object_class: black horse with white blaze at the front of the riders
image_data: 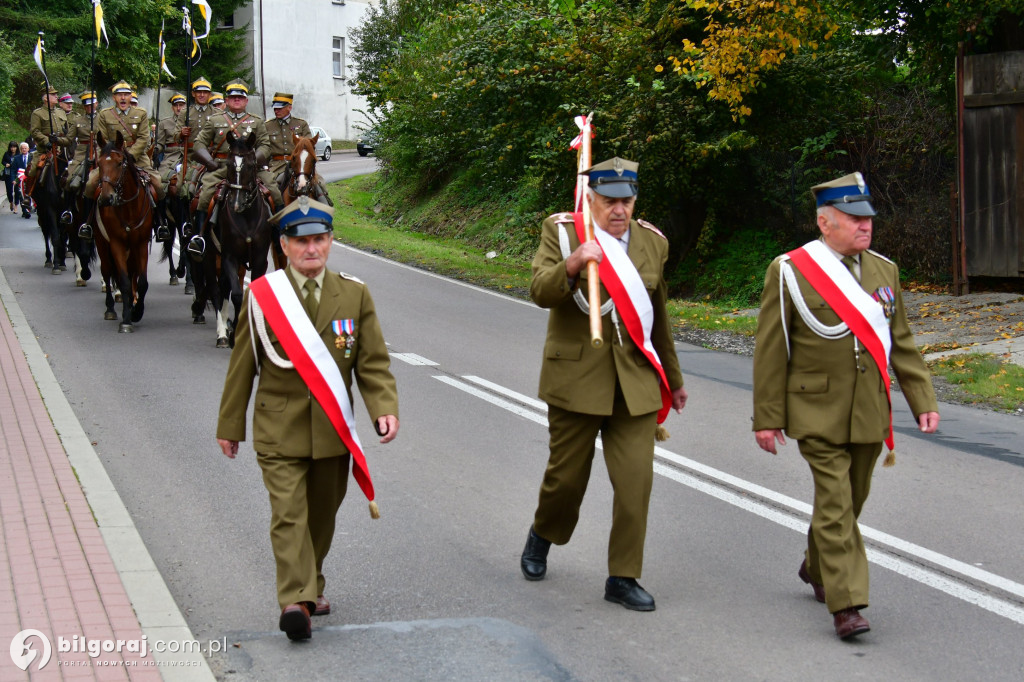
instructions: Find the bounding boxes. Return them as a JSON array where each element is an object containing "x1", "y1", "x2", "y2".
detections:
[{"x1": 193, "y1": 132, "x2": 273, "y2": 348}]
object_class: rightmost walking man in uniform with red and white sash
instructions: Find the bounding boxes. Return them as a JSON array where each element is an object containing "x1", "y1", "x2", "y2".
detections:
[{"x1": 754, "y1": 173, "x2": 939, "y2": 639}]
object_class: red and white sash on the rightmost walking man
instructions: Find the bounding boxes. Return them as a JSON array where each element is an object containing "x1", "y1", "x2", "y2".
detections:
[{"x1": 786, "y1": 240, "x2": 893, "y2": 450}]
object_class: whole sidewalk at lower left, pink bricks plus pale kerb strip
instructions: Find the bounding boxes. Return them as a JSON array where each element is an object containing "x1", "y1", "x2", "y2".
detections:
[{"x1": 0, "y1": 262, "x2": 213, "y2": 682}]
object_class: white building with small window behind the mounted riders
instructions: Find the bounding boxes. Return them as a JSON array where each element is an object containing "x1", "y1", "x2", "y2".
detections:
[{"x1": 231, "y1": 0, "x2": 377, "y2": 140}]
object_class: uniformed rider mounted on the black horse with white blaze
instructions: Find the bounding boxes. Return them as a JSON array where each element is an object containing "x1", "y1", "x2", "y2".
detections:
[{"x1": 187, "y1": 80, "x2": 282, "y2": 260}]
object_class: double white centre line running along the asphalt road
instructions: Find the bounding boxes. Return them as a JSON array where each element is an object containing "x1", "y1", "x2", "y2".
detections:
[{"x1": 434, "y1": 376, "x2": 1024, "y2": 625}]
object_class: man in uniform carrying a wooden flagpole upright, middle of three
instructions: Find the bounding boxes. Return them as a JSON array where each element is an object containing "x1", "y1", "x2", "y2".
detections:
[{"x1": 520, "y1": 157, "x2": 687, "y2": 611}]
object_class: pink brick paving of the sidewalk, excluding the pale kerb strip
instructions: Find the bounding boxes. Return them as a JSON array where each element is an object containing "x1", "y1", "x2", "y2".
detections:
[{"x1": 0, "y1": 290, "x2": 161, "y2": 680}]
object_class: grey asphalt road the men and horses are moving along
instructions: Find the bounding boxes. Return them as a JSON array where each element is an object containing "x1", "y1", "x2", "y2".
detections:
[{"x1": 0, "y1": 161, "x2": 1024, "y2": 680}]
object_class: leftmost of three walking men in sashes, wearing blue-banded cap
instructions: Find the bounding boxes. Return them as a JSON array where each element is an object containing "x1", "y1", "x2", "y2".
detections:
[{"x1": 217, "y1": 196, "x2": 398, "y2": 640}]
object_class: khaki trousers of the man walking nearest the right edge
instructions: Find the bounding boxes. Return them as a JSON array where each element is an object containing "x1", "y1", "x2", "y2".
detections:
[{"x1": 799, "y1": 438, "x2": 882, "y2": 613}]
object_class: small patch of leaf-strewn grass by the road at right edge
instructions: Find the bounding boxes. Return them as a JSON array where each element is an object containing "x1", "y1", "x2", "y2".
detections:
[{"x1": 928, "y1": 353, "x2": 1024, "y2": 412}]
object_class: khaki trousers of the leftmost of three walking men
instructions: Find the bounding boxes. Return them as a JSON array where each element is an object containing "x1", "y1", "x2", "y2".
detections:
[{"x1": 257, "y1": 453, "x2": 350, "y2": 610}]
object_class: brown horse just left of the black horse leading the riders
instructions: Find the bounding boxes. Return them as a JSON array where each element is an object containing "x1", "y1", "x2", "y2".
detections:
[{"x1": 95, "y1": 130, "x2": 154, "y2": 334}]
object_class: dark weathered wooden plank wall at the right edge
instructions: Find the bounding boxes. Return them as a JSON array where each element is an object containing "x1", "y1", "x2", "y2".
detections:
[{"x1": 963, "y1": 51, "x2": 1024, "y2": 278}]
